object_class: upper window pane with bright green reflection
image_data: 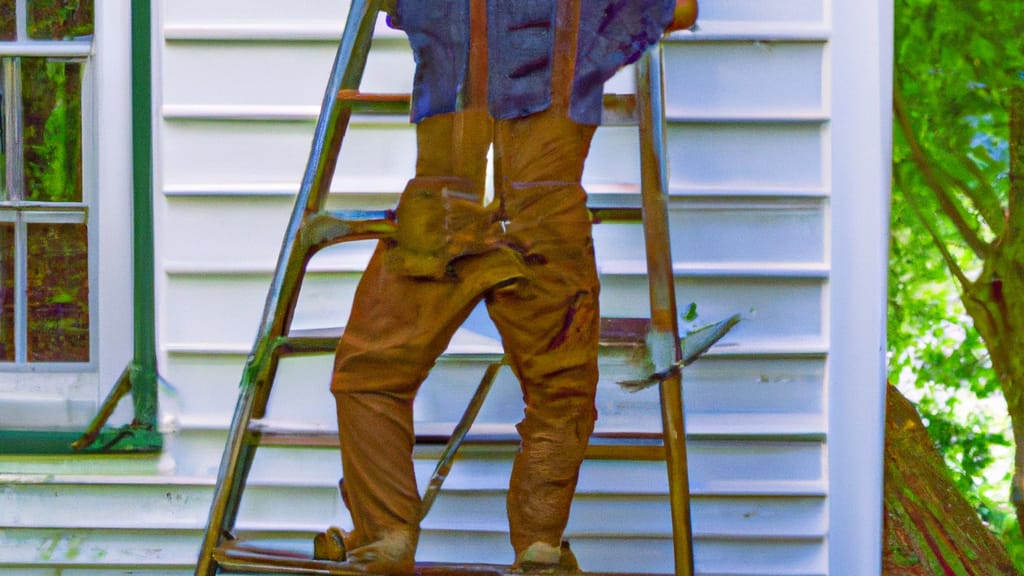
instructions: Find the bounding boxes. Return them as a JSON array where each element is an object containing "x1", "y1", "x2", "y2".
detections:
[{"x1": 22, "y1": 58, "x2": 82, "y2": 202}]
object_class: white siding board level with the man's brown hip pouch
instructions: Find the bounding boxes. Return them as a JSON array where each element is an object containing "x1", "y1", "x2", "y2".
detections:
[{"x1": 164, "y1": 197, "x2": 825, "y2": 272}]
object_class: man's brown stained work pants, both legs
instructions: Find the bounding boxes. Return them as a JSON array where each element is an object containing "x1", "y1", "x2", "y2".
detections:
[{"x1": 332, "y1": 105, "x2": 600, "y2": 553}]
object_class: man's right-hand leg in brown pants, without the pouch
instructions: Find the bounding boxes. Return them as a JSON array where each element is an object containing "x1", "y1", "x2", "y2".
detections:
[{"x1": 487, "y1": 105, "x2": 600, "y2": 563}]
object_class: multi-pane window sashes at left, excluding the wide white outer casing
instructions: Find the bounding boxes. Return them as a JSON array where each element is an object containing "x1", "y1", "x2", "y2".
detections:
[{"x1": 0, "y1": 0, "x2": 93, "y2": 370}]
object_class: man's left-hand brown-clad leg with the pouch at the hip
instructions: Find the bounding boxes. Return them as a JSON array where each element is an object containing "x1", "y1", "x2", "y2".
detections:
[{"x1": 331, "y1": 108, "x2": 522, "y2": 572}]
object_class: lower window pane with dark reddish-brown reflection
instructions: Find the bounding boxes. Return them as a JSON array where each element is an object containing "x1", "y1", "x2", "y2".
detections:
[{"x1": 28, "y1": 224, "x2": 89, "y2": 362}]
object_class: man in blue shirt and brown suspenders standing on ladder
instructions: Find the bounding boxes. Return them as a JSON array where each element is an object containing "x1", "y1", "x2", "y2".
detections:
[{"x1": 323, "y1": 0, "x2": 696, "y2": 574}]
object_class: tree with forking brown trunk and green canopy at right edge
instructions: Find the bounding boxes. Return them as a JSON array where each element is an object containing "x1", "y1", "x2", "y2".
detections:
[{"x1": 893, "y1": 0, "x2": 1024, "y2": 537}]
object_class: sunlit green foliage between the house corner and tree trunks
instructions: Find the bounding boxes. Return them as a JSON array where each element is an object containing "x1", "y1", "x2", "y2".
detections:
[{"x1": 889, "y1": 0, "x2": 1024, "y2": 569}]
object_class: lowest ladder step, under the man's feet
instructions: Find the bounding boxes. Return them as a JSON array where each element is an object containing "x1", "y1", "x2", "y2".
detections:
[{"x1": 213, "y1": 540, "x2": 667, "y2": 576}]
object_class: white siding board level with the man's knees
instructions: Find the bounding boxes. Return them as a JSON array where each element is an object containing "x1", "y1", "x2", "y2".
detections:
[{"x1": 163, "y1": 355, "x2": 824, "y2": 435}]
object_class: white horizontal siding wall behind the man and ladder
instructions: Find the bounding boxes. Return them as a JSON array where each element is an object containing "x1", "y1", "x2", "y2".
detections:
[{"x1": 160, "y1": 2, "x2": 829, "y2": 575}]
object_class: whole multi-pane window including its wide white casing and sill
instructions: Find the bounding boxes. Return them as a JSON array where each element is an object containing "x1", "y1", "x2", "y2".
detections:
[{"x1": 0, "y1": 0, "x2": 119, "y2": 438}]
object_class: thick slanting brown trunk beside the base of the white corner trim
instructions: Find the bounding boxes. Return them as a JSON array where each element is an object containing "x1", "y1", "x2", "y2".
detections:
[{"x1": 883, "y1": 386, "x2": 1018, "y2": 576}]
